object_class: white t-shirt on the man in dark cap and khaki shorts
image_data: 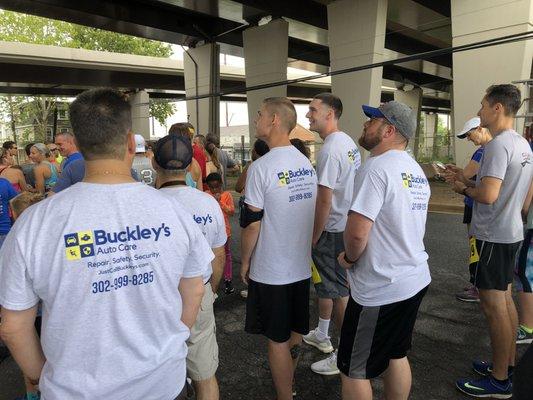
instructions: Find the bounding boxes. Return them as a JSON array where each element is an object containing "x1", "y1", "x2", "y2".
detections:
[{"x1": 160, "y1": 186, "x2": 228, "y2": 283}]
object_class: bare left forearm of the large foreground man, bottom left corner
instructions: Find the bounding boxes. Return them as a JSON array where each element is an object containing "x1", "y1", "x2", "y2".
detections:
[{"x1": 0, "y1": 305, "x2": 45, "y2": 384}]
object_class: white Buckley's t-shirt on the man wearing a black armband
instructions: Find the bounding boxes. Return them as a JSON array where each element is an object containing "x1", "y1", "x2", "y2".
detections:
[{"x1": 245, "y1": 146, "x2": 317, "y2": 285}]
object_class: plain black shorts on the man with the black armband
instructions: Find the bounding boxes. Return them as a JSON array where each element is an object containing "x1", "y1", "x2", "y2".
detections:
[{"x1": 244, "y1": 279, "x2": 310, "y2": 343}]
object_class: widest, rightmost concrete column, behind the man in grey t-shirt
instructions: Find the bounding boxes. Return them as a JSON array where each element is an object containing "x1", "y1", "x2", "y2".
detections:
[{"x1": 451, "y1": 0, "x2": 533, "y2": 167}]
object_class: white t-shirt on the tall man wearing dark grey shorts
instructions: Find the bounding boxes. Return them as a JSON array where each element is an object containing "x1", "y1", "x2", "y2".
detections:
[{"x1": 316, "y1": 132, "x2": 361, "y2": 232}]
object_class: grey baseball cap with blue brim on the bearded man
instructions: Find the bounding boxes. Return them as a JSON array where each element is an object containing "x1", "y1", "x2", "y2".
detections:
[{"x1": 363, "y1": 101, "x2": 416, "y2": 139}]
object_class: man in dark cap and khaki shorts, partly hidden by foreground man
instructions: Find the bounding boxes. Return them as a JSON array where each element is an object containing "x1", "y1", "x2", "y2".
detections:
[{"x1": 153, "y1": 135, "x2": 227, "y2": 400}]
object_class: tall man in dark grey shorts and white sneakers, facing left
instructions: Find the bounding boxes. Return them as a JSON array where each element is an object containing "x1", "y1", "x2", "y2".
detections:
[{"x1": 303, "y1": 93, "x2": 361, "y2": 375}]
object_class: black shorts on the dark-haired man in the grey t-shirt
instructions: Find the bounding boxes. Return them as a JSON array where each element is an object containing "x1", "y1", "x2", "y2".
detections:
[{"x1": 469, "y1": 239, "x2": 521, "y2": 290}]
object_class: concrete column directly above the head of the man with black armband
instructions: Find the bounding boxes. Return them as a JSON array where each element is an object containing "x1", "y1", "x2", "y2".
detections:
[{"x1": 242, "y1": 18, "x2": 289, "y2": 143}]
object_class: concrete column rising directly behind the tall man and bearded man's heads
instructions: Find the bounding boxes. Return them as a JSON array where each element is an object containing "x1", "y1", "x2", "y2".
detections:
[{"x1": 328, "y1": 0, "x2": 387, "y2": 148}]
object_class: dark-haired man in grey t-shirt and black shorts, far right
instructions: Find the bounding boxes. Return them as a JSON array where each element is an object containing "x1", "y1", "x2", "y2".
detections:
[{"x1": 448, "y1": 84, "x2": 533, "y2": 399}]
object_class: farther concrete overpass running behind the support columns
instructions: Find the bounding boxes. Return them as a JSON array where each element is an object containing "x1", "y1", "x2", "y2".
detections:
[{"x1": 0, "y1": 41, "x2": 450, "y2": 112}]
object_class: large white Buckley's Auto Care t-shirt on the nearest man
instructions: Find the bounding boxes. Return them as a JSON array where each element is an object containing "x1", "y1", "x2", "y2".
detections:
[{"x1": 0, "y1": 182, "x2": 213, "y2": 400}]
